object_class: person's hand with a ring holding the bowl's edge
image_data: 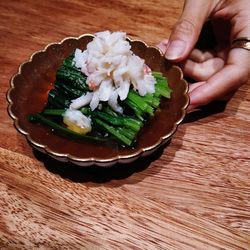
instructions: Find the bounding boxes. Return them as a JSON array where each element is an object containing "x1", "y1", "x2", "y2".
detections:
[{"x1": 158, "y1": 0, "x2": 250, "y2": 111}]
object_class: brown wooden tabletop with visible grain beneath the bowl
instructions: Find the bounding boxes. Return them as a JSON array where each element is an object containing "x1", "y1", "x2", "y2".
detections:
[{"x1": 0, "y1": 0, "x2": 250, "y2": 249}]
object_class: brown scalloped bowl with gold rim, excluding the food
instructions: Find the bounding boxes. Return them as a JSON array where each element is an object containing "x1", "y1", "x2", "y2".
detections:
[{"x1": 7, "y1": 34, "x2": 189, "y2": 166}]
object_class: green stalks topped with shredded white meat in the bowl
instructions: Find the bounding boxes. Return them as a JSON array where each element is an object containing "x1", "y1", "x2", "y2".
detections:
[{"x1": 29, "y1": 31, "x2": 171, "y2": 147}]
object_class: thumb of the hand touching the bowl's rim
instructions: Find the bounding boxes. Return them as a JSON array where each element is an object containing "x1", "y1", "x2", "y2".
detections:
[{"x1": 165, "y1": 0, "x2": 215, "y2": 62}]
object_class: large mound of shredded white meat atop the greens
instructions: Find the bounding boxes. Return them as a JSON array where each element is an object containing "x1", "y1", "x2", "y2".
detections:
[{"x1": 70, "y1": 31, "x2": 156, "y2": 113}]
